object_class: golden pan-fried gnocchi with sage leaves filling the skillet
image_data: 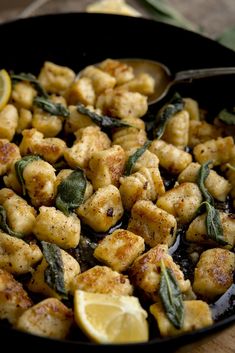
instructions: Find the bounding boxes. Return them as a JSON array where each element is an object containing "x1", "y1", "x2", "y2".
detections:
[{"x1": 0, "y1": 58, "x2": 235, "y2": 343}]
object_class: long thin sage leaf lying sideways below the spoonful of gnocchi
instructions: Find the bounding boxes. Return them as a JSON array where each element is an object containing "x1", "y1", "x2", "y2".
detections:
[{"x1": 77, "y1": 103, "x2": 130, "y2": 128}]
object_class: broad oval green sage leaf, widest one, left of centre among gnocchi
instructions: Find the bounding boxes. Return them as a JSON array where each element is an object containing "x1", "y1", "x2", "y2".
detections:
[{"x1": 55, "y1": 169, "x2": 87, "y2": 216}]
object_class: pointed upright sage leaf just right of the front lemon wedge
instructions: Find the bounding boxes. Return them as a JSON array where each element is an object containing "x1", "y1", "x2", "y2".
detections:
[{"x1": 159, "y1": 260, "x2": 184, "y2": 329}]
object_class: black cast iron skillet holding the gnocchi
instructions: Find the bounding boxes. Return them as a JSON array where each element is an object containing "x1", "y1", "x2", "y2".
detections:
[{"x1": 0, "y1": 13, "x2": 235, "y2": 353}]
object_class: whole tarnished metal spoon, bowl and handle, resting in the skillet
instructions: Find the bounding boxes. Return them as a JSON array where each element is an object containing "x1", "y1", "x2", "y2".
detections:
[{"x1": 114, "y1": 59, "x2": 235, "y2": 105}]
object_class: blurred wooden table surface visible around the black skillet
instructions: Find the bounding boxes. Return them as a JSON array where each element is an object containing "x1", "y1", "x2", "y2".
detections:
[{"x1": 0, "y1": 0, "x2": 235, "y2": 353}]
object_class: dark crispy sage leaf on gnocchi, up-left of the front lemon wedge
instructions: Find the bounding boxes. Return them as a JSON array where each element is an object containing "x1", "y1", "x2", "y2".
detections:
[{"x1": 41, "y1": 241, "x2": 67, "y2": 299}]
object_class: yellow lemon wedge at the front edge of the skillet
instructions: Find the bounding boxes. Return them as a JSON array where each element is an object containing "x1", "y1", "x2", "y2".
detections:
[{"x1": 74, "y1": 290, "x2": 148, "y2": 343}]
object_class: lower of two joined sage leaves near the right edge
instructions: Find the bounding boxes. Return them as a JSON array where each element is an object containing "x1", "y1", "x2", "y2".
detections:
[{"x1": 202, "y1": 201, "x2": 228, "y2": 245}]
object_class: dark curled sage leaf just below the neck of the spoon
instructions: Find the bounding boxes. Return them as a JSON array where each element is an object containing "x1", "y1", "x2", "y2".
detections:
[{"x1": 154, "y1": 93, "x2": 185, "y2": 139}]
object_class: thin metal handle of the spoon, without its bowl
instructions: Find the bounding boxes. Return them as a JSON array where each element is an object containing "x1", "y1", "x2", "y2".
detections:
[{"x1": 174, "y1": 67, "x2": 235, "y2": 83}]
